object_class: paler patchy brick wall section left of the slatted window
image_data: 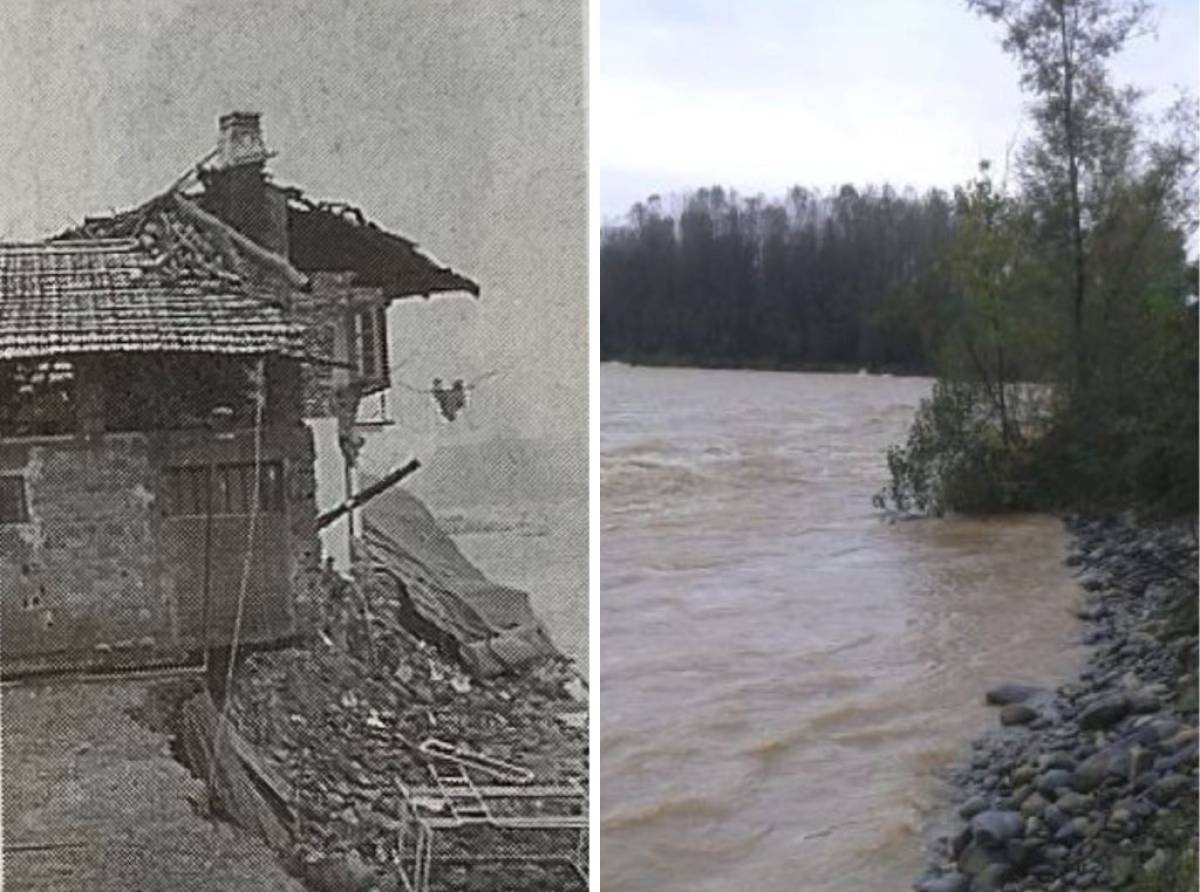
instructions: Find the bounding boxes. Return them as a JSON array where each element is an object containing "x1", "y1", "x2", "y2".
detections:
[{"x1": 0, "y1": 435, "x2": 164, "y2": 663}]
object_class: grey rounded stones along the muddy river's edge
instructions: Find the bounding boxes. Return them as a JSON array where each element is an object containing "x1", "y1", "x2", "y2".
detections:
[{"x1": 914, "y1": 517, "x2": 1198, "y2": 892}]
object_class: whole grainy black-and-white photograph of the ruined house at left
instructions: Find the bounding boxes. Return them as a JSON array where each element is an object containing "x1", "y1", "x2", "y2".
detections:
[{"x1": 0, "y1": 0, "x2": 590, "y2": 892}]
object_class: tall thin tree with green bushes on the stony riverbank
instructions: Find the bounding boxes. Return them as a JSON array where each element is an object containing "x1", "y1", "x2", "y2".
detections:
[{"x1": 880, "y1": 0, "x2": 1200, "y2": 516}]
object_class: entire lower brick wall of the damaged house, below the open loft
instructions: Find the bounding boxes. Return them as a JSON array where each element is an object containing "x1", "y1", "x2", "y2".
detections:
[{"x1": 0, "y1": 423, "x2": 320, "y2": 671}]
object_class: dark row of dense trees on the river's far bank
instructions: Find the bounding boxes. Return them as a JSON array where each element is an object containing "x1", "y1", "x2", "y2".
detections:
[{"x1": 600, "y1": 185, "x2": 954, "y2": 371}]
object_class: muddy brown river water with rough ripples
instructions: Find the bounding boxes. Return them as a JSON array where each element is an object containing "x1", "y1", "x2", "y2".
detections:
[{"x1": 600, "y1": 366, "x2": 1079, "y2": 892}]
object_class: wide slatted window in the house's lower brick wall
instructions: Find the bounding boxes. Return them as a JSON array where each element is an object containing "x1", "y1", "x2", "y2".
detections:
[{"x1": 164, "y1": 461, "x2": 283, "y2": 517}]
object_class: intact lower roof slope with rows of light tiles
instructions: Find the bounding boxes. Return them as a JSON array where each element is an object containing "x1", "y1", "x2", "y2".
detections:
[{"x1": 0, "y1": 239, "x2": 301, "y2": 360}]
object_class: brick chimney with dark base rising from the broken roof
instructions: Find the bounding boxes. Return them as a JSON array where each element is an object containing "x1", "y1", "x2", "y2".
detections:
[{"x1": 202, "y1": 112, "x2": 288, "y2": 257}]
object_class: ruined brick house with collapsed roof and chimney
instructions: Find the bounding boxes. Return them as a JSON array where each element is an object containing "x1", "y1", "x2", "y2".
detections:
[{"x1": 0, "y1": 113, "x2": 499, "y2": 672}]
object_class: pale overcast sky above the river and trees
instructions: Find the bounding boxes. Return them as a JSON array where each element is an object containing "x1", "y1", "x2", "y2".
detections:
[{"x1": 604, "y1": 0, "x2": 1200, "y2": 218}]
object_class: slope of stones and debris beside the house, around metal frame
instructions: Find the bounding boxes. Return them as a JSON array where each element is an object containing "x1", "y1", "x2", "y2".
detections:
[{"x1": 229, "y1": 554, "x2": 588, "y2": 890}]
